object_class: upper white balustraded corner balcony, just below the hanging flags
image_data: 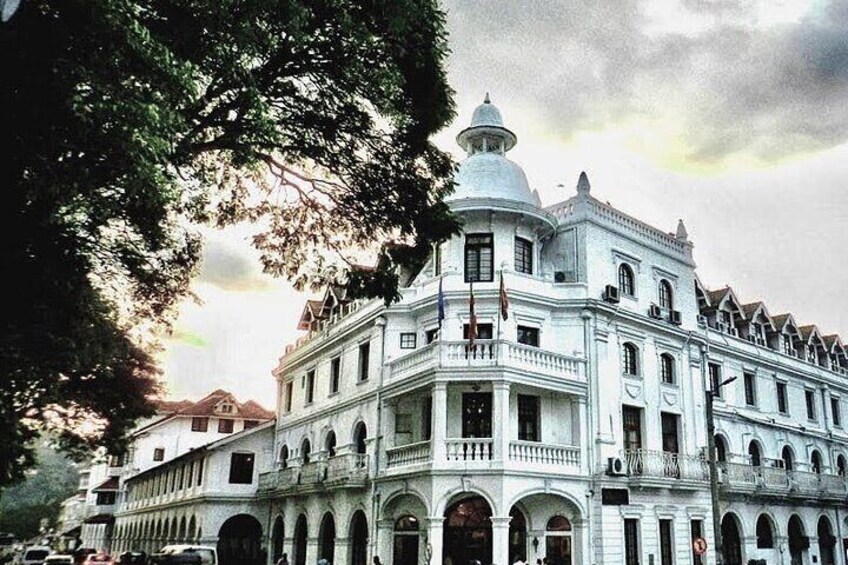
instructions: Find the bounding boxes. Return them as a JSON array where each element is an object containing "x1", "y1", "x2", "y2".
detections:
[{"x1": 388, "y1": 339, "x2": 584, "y2": 381}]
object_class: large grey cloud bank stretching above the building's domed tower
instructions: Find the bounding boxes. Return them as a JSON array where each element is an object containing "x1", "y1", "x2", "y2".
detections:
[{"x1": 447, "y1": 0, "x2": 848, "y2": 163}]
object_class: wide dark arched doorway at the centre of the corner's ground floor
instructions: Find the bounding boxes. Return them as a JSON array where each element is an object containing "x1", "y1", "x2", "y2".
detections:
[{"x1": 442, "y1": 496, "x2": 492, "y2": 565}]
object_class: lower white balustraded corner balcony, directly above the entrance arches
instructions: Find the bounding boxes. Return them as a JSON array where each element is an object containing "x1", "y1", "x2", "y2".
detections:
[{"x1": 386, "y1": 438, "x2": 582, "y2": 474}]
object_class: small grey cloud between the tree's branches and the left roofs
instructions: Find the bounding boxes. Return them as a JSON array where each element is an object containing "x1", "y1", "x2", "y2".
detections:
[{"x1": 199, "y1": 239, "x2": 270, "y2": 291}]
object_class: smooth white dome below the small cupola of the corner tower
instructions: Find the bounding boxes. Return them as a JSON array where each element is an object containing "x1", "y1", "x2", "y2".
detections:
[{"x1": 445, "y1": 153, "x2": 538, "y2": 206}]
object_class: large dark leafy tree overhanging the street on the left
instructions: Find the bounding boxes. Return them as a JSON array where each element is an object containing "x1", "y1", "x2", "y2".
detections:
[{"x1": 0, "y1": 0, "x2": 457, "y2": 485}]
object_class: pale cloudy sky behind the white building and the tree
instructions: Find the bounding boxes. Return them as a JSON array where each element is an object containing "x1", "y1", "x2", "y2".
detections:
[{"x1": 156, "y1": 0, "x2": 848, "y2": 407}]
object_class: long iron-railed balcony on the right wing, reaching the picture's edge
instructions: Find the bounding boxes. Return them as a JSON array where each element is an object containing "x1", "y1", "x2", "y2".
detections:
[{"x1": 719, "y1": 462, "x2": 848, "y2": 500}]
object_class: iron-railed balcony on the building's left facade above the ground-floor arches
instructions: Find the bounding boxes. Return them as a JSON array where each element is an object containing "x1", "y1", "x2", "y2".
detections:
[{"x1": 258, "y1": 453, "x2": 369, "y2": 494}]
